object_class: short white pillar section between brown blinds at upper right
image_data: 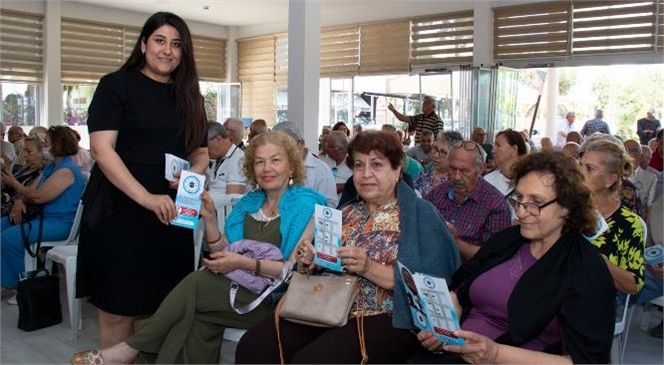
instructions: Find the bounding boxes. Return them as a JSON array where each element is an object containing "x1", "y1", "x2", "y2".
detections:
[{"x1": 473, "y1": 1, "x2": 493, "y2": 67}]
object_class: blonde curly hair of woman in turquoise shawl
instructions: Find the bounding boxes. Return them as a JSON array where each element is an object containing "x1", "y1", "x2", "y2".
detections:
[{"x1": 242, "y1": 131, "x2": 306, "y2": 186}]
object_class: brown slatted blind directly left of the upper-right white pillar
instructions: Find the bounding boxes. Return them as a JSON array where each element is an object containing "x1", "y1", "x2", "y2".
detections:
[{"x1": 410, "y1": 10, "x2": 474, "y2": 66}]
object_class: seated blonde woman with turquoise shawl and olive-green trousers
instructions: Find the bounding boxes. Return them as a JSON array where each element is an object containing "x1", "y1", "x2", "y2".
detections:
[{"x1": 72, "y1": 132, "x2": 326, "y2": 364}]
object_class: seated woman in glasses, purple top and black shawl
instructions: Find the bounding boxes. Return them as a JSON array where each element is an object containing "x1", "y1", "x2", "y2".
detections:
[{"x1": 414, "y1": 152, "x2": 615, "y2": 364}]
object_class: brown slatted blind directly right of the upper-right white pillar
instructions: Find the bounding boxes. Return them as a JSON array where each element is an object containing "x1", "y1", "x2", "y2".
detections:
[{"x1": 493, "y1": 1, "x2": 571, "y2": 61}]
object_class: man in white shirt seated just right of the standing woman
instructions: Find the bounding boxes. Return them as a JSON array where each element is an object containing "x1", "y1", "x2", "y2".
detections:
[{"x1": 207, "y1": 122, "x2": 247, "y2": 208}]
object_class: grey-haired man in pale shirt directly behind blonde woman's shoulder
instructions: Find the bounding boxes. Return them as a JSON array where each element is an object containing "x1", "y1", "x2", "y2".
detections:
[{"x1": 272, "y1": 122, "x2": 339, "y2": 208}]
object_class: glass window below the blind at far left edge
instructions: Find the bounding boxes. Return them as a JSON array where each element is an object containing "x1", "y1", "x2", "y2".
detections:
[{"x1": 0, "y1": 82, "x2": 40, "y2": 126}]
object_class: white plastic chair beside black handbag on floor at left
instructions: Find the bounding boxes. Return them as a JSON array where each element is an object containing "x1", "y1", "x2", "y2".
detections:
[{"x1": 45, "y1": 245, "x2": 83, "y2": 341}]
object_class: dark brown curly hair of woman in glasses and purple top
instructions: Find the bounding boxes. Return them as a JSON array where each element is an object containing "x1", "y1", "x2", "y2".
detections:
[{"x1": 513, "y1": 151, "x2": 597, "y2": 236}]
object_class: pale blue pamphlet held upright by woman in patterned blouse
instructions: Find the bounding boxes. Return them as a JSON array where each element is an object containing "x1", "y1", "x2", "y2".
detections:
[{"x1": 314, "y1": 204, "x2": 342, "y2": 272}]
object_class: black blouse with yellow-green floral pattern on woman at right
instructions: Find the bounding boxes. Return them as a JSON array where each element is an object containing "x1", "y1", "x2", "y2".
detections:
[{"x1": 592, "y1": 205, "x2": 646, "y2": 290}]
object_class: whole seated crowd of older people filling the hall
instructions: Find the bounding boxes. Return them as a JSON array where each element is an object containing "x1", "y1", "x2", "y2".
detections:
[{"x1": 2, "y1": 114, "x2": 664, "y2": 364}]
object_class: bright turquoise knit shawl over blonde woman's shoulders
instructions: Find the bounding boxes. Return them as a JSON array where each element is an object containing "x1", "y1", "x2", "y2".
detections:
[{"x1": 224, "y1": 185, "x2": 327, "y2": 259}]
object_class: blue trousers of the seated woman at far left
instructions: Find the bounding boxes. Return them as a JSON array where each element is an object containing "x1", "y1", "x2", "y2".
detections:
[{"x1": 0, "y1": 217, "x2": 73, "y2": 288}]
